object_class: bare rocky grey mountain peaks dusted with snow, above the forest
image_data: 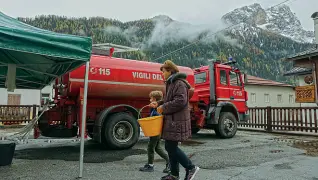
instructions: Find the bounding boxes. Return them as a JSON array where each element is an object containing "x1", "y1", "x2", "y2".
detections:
[{"x1": 222, "y1": 3, "x2": 314, "y2": 43}]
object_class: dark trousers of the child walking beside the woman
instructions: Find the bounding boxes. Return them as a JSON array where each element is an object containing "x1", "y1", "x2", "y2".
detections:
[{"x1": 148, "y1": 136, "x2": 169, "y2": 164}]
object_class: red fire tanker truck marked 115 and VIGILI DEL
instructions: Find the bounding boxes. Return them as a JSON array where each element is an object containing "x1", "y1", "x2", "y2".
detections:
[{"x1": 38, "y1": 47, "x2": 248, "y2": 149}]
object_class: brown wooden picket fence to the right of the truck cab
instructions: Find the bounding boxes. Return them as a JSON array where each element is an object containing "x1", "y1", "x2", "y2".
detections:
[{"x1": 239, "y1": 107, "x2": 318, "y2": 133}]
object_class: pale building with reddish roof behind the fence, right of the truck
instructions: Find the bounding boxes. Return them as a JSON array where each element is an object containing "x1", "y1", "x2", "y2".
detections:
[{"x1": 245, "y1": 75, "x2": 300, "y2": 107}]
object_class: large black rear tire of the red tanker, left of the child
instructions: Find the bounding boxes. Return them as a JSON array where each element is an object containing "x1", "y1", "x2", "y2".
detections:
[{"x1": 102, "y1": 113, "x2": 140, "y2": 149}]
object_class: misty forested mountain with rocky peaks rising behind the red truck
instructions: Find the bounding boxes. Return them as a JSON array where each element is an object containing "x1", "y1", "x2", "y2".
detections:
[{"x1": 18, "y1": 4, "x2": 312, "y2": 83}]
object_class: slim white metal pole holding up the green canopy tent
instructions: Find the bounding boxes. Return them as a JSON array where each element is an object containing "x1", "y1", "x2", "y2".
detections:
[{"x1": 79, "y1": 61, "x2": 89, "y2": 178}]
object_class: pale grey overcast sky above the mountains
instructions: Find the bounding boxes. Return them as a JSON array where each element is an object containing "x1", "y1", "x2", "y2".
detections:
[{"x1": 0, "y1": 0, "x2": 318, "y2": 30}]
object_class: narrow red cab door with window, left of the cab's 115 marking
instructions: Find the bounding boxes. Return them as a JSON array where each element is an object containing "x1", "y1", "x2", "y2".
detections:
[{"x1": 215, "y1": 68, "x2": 230, "y2": 101}]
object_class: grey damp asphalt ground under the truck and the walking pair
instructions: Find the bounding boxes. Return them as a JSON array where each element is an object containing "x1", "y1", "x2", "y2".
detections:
[{"x1": 0, "y1": 131, "x2": 318, "y2": 180}]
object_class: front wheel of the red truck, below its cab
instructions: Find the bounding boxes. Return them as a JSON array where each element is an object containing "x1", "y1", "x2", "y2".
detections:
[{"x1": 215, "y1": 112, "x2": 237, "y2": 138}]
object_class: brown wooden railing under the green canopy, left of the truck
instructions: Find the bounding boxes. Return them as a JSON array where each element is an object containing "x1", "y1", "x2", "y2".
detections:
[{"x1": 0, "y1": 105, "x2": 39, "y2": 125}]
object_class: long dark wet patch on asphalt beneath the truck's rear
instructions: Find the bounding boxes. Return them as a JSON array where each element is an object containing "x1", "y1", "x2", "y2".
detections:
[{"x1": 14, "y1": 144, "x2": 147, "y2": 163}]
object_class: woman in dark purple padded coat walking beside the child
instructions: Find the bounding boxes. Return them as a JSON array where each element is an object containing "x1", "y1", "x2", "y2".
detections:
[{"x1": 150, "y1": 60, "x2": 199, "y2": 180}]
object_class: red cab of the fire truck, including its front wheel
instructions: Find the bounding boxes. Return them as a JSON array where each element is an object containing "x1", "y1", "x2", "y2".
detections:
[{"x1": 192, "y1": 59, "x2": 249, "y2": 138}]
